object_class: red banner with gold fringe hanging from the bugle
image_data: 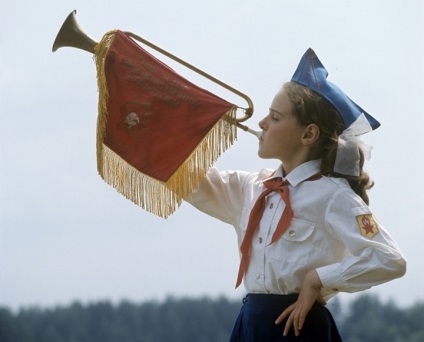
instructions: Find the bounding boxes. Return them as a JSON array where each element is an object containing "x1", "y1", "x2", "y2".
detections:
[{"x1": 95, "y1": 30, "x2": 237, "y2": 218}]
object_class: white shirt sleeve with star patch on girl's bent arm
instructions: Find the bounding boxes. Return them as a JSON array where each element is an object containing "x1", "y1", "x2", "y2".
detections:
[{"x1": 317, "y1": 191, "x2": 406, "y2": 293}]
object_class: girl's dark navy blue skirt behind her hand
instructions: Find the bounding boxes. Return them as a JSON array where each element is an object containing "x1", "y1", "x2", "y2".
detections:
[{"x1": 230, "y1": 294, "x2": 342, "y2": 342}]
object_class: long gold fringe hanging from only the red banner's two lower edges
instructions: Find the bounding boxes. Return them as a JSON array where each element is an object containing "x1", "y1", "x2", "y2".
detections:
[{"x1": 99, "y1": 108, "x2": 237, "y2": 219}]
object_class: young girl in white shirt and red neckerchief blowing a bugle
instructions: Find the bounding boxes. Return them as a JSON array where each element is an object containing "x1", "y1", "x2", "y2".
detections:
[{"x1": 187, "y1": 49, "x2": 406, "y2": 342}]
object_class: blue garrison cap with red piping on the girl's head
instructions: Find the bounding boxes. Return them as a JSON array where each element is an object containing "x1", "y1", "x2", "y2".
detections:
[{"x1": 291, "y1": 48, "x2": 380, "y2": 129}]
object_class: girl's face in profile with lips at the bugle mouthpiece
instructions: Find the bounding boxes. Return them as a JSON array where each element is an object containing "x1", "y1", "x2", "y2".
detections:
[{"x1": 258, "y1": 89, "x2": 309, "y2": 174}]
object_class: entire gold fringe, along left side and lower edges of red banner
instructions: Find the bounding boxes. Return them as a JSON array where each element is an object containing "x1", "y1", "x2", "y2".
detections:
[{"x1": 94, "y1": 30, "x2": 237, "y2": 219}]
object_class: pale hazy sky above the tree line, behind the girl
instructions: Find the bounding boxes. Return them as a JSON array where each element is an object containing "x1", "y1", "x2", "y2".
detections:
[{"x1": 0, "y1": 0, "x2": 424, "y2": 309}]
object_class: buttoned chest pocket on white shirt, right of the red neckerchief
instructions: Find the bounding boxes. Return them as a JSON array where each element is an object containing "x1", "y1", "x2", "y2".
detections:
[{"x1": 266, "y1": 218, "x2": 315, "y2": 265}]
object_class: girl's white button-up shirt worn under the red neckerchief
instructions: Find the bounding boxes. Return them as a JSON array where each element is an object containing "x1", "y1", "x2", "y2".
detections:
[{"x1": 186, "y1": 160, "x2": 406, "y2": 298}]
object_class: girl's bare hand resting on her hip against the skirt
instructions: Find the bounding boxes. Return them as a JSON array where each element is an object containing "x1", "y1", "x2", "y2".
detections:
[{"x1": 275, "y1": 270, "x2": 326, "y2": 336}]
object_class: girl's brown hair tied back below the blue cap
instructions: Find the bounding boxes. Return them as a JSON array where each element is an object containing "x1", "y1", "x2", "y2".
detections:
[{"x1": 283, "y1": 82, "x2": 374, "y2": 204}]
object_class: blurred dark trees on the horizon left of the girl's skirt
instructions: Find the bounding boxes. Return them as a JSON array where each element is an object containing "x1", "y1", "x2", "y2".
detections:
[{"x1": 0, "y1": 298, "x2": 240, "y2": 342}]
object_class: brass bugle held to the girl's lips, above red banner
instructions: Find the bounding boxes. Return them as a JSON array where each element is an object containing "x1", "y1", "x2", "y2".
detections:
[{"x1": 52, "y1": 10, "x2": 261, "y2": 138}]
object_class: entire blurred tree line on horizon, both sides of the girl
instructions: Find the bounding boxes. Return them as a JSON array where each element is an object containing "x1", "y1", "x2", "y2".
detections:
[{"x1": 0, "y1": 295, "x2": 424, "y2": 342}]
